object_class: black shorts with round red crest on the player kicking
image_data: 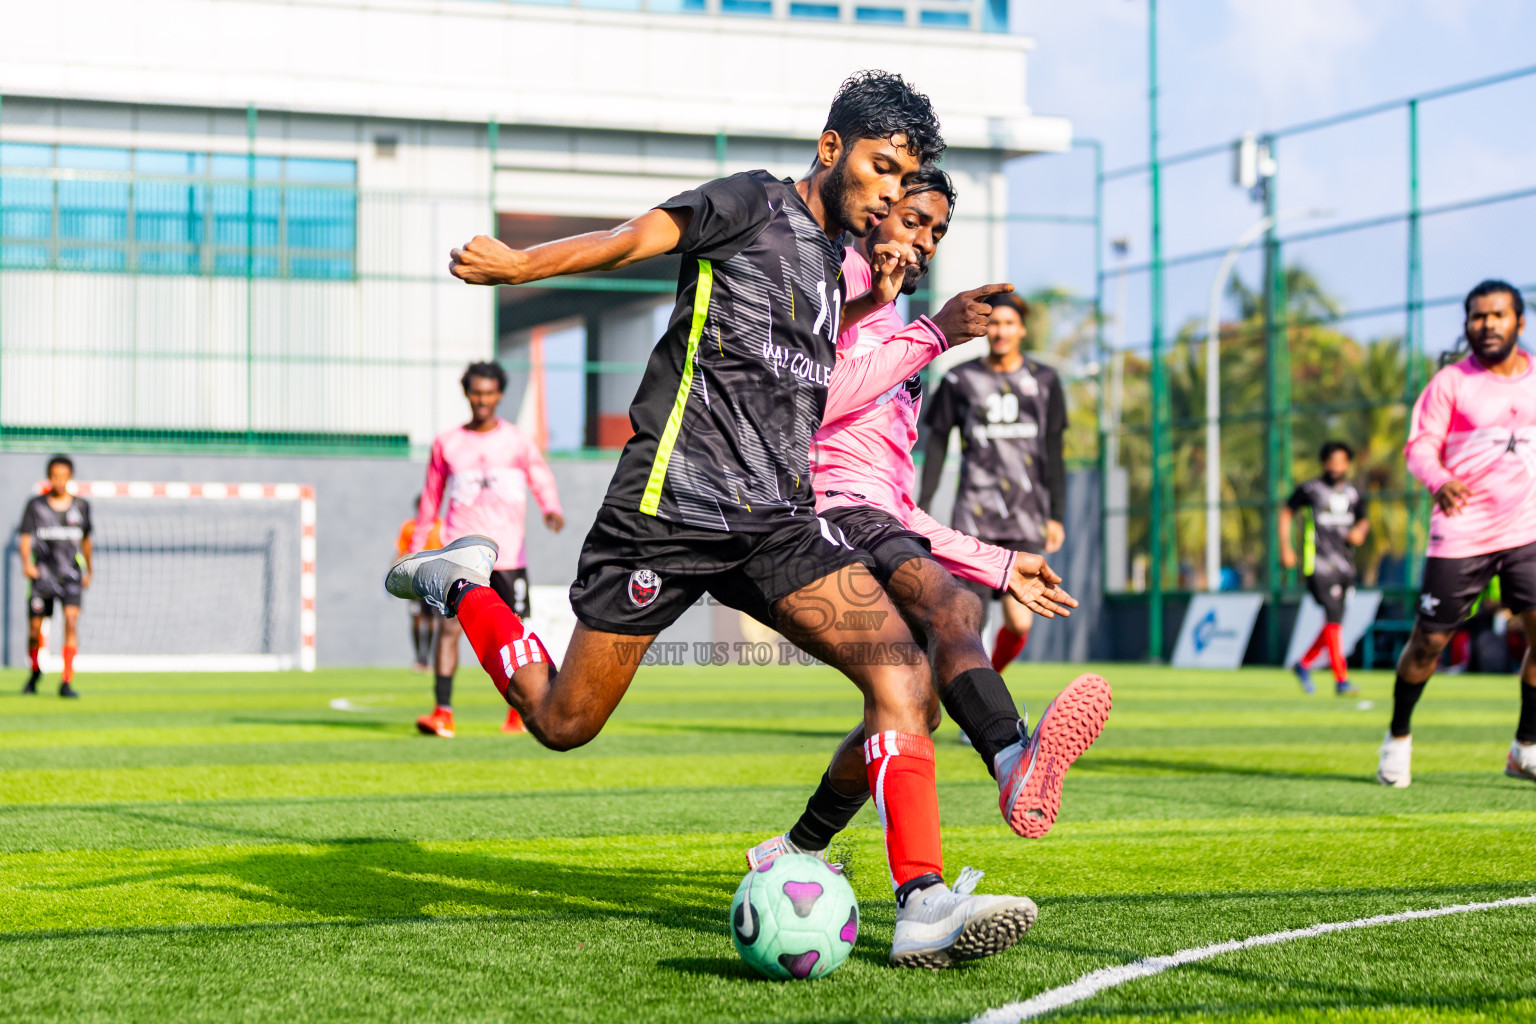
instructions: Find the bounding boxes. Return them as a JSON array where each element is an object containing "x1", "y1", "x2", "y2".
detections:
[{"x1": 571, "y1": 505, "x2": 874, "y2": 636}]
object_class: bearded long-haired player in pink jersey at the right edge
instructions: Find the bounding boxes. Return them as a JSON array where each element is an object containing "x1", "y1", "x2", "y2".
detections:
[{"x1": 1376, "y1": 281, "x2": 1536, "y2": 788}]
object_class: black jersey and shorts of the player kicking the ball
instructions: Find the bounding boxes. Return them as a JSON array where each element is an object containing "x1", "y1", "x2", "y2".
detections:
[{"x1": 571, "y1": 170, "x2": 869, "y2": 636}]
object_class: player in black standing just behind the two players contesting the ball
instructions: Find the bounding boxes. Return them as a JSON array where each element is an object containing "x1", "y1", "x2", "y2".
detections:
[{"x1": 917, "y1": 295, "x2": 1066, "y2": 672}]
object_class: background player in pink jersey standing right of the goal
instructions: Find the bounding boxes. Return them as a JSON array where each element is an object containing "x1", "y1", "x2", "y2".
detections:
[{"x1": 412, "y1": 362, "x2": 565, "y2": 737}]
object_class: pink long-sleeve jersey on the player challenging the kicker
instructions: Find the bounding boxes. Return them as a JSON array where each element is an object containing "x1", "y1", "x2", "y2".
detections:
[{"x1": 811, "y1": 247, "x2": 1014, "y2": 590}]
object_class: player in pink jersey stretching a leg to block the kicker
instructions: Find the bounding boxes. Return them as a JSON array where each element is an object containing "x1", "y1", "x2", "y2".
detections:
[{"x1": 746, "y1": 166, "x2": 1111, "y2": 866}]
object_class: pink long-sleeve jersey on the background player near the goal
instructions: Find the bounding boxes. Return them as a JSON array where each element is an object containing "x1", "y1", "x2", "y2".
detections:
[{"x1": 412, "y1": 419, "x2": 561, "y2": 570}]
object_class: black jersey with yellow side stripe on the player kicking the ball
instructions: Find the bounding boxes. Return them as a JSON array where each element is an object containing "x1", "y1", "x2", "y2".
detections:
[{"x1": 604, "y1": 170, "x2": 843, "y2": 531}]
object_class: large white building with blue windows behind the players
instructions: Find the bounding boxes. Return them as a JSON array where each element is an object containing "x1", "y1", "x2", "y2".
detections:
[{"x1": 0, "y1": 0, "x2": 1071, "y2": 451}]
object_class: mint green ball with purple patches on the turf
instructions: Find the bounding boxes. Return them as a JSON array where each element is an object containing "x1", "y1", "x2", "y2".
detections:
[{"x1": 731, "y1": 854, "x2": 859, "y2": 981}]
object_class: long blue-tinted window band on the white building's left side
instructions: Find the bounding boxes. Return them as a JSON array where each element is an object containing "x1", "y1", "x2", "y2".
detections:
[{"x1": 0, "y1": 143, "x2": 358, "y2": 281}]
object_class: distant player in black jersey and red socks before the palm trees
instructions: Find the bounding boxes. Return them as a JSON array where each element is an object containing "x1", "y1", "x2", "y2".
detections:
[{"x1": 1279, "y1": 441, "x2": 1370, "y2": 697}]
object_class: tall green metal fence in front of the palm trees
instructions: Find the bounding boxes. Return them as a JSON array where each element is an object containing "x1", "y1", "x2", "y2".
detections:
[{"x1": 1095, "y1": 68, "x2": 1536, "y2": 659}]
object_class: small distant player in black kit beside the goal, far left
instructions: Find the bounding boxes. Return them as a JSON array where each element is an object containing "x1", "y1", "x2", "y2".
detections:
[{"x1": 17, "y1": 454, "x2": 91, "y2": 697}]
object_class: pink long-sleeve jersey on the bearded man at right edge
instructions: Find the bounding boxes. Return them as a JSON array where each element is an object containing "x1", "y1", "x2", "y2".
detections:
[{"x1": 1407, "y1": 356, "x2": 1536, "y2": 559}]
